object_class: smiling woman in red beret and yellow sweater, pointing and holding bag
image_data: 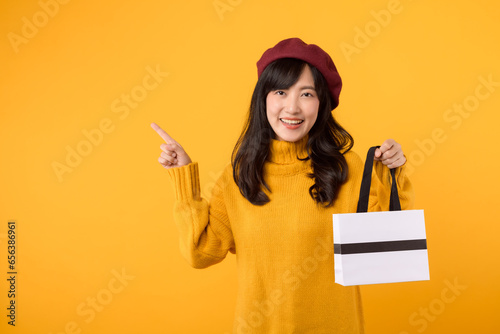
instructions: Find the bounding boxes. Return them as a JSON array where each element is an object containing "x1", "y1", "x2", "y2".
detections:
[{"x1": 152, "y1": 38, "x2": 413, "y2": 334}]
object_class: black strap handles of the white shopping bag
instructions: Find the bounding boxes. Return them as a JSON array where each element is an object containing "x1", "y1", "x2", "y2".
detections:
[{"x1": 357, "y1": 146, "x2": 401, "y2": 212}]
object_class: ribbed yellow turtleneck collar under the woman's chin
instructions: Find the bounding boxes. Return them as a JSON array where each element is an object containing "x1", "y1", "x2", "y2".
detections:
[{"x1": 266, "y1": 135, "x2": 310, "y2": 174}]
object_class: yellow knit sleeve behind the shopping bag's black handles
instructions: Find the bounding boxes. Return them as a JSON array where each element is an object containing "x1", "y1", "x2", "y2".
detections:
[{"x1": 368, "y1": 161, "x2": 415, "y2": 212}]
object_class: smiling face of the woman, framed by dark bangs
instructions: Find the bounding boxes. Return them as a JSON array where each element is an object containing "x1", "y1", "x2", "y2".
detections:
[{"x1": 266, "y1": 65, "x2": 319, "y2": 142}]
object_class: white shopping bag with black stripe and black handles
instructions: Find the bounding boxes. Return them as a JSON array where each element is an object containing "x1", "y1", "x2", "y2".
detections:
[{"x1": 333, "y1": 147, "x2": 430, "y2": 286}]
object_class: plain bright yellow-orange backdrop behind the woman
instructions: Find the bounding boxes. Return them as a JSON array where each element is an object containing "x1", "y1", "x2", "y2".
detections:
[{"x1": 0, "y1": 0, "x2": 500, "y2": 334}]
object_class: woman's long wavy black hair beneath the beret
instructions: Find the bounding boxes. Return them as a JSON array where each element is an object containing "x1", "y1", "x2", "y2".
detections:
[{"x1": 231, "y1": 58, "x2": 354, "y2": 207}]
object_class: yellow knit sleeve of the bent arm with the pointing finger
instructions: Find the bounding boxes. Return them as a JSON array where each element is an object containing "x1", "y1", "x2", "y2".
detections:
[{"x1": 167, "y1": 162, "x2": 235, "y2": 268}]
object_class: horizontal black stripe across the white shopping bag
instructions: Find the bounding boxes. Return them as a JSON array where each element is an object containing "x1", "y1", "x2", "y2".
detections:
[{"x1": 333, "y1": 239, "x2": 427, "y2": 255}]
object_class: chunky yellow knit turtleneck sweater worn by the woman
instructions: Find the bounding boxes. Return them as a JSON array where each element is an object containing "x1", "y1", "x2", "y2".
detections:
[{"x1": 167, "y1": 137, "x2": 414, "y2": 334}]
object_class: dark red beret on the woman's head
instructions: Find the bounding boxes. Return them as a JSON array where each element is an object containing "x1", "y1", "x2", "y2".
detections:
[{"x1": 257, "y1": 38, "x2": 342, "y2": 108}]
